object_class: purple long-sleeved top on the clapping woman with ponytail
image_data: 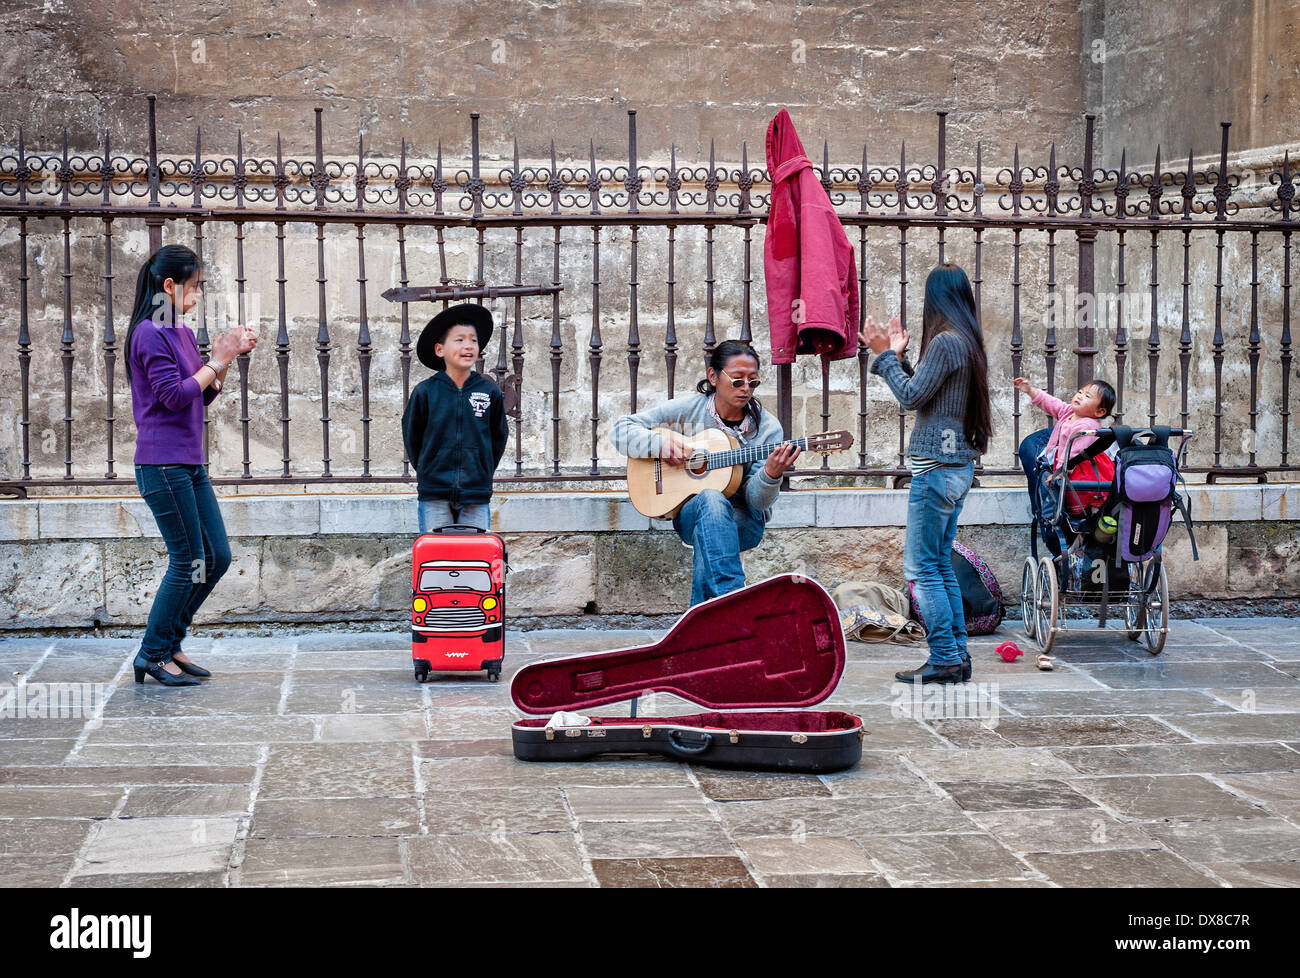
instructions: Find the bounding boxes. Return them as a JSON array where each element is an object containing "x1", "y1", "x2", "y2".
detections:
[{"x1": 130, "y1": 320, "x2": 217, "y2": 466}]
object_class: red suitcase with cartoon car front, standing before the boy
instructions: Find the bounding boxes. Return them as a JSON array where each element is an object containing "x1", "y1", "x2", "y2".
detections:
[{"x1": 411, "y1": 527, "x2": 506, "y2": 683}]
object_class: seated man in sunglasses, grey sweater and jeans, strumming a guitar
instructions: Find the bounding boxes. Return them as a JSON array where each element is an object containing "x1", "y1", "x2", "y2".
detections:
[{"x1": 612, "y1": 339, "x2": 800, "y2": 605}]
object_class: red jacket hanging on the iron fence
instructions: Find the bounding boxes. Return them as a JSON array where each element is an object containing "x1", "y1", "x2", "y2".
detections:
[{"x1": 763, "y1": 109, "x2": 858, "y2": 363}]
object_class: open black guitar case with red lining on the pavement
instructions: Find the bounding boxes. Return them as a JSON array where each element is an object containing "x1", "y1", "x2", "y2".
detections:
[{"x1": 510, "y1": 575, "x2": 865, "y2": 773}]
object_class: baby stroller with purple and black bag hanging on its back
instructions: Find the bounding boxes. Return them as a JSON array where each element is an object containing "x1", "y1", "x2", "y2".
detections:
[{"x1": 1021, "y1": 427, "x2": 1200, "y2": 655}]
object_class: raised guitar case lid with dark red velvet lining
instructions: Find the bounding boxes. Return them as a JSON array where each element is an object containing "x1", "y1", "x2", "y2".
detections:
[{"x1": 510, "y1": 575, "x2": 844, "y2": 712}]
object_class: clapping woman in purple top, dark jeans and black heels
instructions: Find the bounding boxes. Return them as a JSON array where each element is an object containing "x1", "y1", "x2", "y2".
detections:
[{"x1": 125, "y1": 245, "x2": 257, "y2": 685}]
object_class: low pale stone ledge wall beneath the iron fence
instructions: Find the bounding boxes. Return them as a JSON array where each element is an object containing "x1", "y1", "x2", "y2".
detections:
[{"x1": 0, "y1": 485, "x2": 1300, "y2": 629}]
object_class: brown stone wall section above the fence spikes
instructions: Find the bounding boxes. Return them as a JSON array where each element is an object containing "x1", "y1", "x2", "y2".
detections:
[{"x1": 0, "y1": 0, "x2": 1095, "y2": 159}]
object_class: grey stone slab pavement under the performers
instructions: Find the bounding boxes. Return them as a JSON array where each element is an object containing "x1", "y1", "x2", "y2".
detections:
[{"x1": 0, "y1": 618, "x2": 1300, "y2": 887}]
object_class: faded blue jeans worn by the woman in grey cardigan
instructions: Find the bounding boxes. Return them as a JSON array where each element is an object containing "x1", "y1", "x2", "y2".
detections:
[{"x1": 902, "y1": 462, "x2": 975, "y2": 666}]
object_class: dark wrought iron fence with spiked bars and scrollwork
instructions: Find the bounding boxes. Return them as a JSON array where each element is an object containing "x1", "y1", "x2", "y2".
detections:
[{"x1": 0, "y1": 96, "x2": 1297, "y2": 494}]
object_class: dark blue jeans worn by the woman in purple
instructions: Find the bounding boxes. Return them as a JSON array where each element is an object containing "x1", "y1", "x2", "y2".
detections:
[{"x1": 135, "y1": 464, "x2": 230, "y2": 662}]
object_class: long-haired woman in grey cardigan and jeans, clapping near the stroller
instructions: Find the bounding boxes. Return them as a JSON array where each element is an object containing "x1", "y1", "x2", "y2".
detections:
[{"x1": 862, "y1": 264, "x2": 993, "y2": 683}]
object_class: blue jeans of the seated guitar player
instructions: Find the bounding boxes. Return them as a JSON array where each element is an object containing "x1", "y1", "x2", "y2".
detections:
[{"x1": 672, "y1": 489, "x2": 764, "y2": 606}]
